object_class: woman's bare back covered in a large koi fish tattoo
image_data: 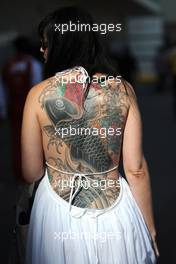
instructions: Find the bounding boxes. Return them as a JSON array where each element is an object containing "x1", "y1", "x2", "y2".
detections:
[{"x1": 32, "y1": 69, "x2": 129, "y2": 208}]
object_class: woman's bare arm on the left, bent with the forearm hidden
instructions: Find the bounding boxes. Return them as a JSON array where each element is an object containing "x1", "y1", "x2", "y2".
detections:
[{"x1": 21, "y1": 86, "x2": 44, "y2": 183}]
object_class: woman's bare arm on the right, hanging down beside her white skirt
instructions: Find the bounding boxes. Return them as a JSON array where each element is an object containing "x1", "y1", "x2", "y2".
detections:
[{"x1": 122, "y1": 84, "x2": 159, "y2": 255}]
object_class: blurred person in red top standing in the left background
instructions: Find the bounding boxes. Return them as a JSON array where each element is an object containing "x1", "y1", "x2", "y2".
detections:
[{"x1": 3, "y1": 36, "x2": 42, "y2": 180}]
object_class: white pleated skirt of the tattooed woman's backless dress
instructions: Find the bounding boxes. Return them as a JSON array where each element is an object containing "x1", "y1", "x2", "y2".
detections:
[{"x1": 26, "y1": 170, "x2": 156, "y2": 264}]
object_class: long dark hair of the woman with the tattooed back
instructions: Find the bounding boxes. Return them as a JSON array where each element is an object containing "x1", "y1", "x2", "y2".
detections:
[{"x1": 38, "y1": 6, "x2": 116, "y2": 78}]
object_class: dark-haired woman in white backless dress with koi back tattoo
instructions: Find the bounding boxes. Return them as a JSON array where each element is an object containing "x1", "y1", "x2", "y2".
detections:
[{"x1": 22, "y1": 7, "x2": 158, "y2": 264}]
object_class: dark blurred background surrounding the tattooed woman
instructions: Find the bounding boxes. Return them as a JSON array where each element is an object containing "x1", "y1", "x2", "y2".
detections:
[{"x1": 0, "y1": 0, "x2": 176, "y2": 264}]
